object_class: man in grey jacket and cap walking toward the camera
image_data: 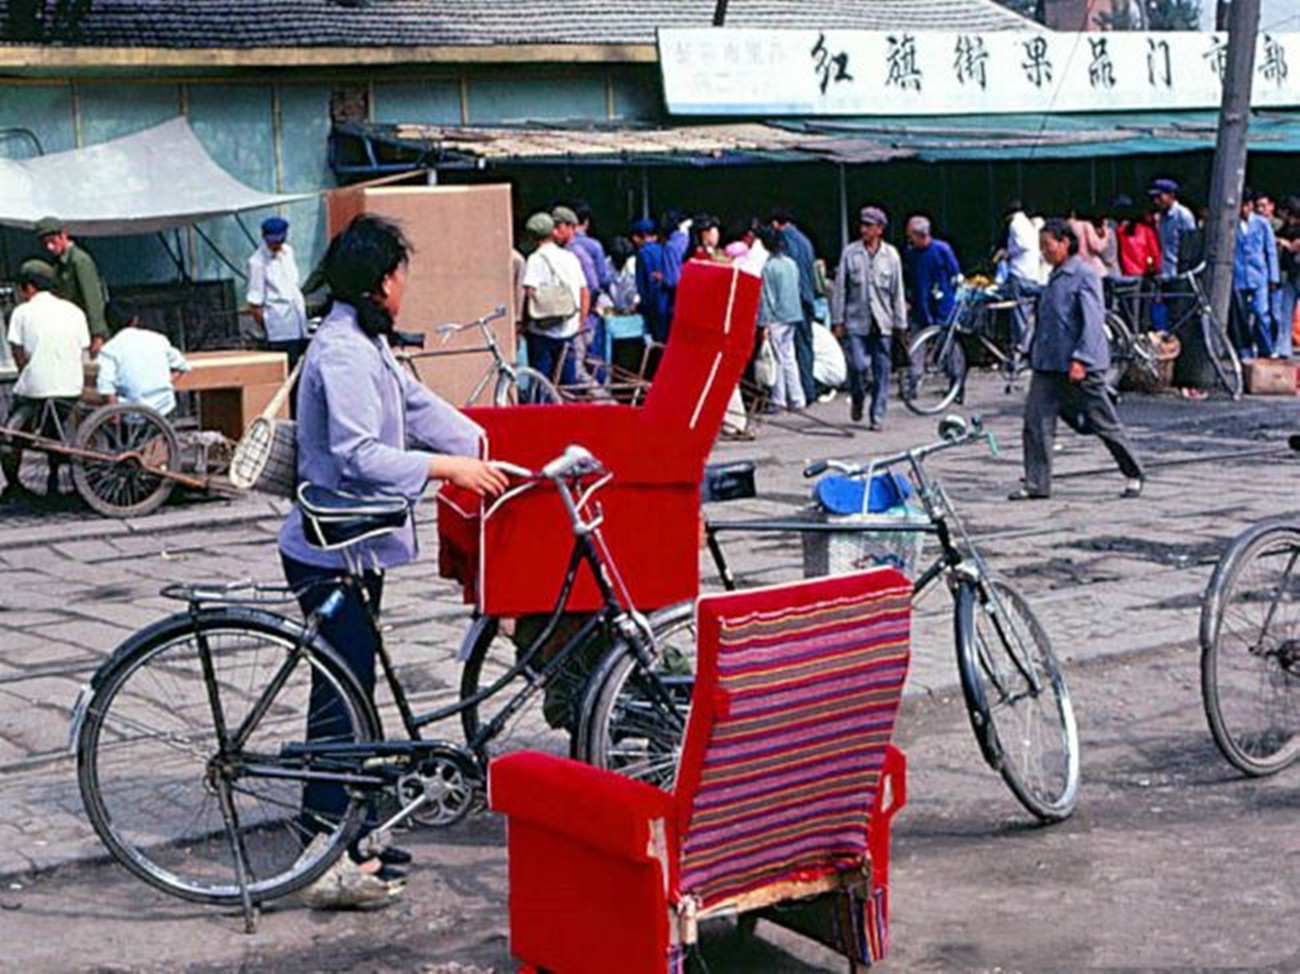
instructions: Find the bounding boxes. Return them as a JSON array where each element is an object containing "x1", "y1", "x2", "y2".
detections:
[{"x1": 831, "y1": 207, "x2": 907, "y2": 429}]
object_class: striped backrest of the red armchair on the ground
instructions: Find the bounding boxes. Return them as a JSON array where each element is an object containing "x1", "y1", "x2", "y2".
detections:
[{"x1": 675, "y1": 570, "x2": 911, "y2": 909}]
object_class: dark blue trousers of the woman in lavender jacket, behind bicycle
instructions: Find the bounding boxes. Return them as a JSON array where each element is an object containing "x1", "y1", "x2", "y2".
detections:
[{"x1": 280, "y1": 555, "x2": 384, "y2": 832}]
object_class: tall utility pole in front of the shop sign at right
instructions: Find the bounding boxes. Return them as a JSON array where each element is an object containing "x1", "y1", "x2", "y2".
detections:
[{"x1": 1188, "y1": 0, "x2": 1260, "y2": 385}]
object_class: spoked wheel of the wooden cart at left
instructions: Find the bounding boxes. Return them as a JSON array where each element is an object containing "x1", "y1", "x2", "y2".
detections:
[{"x1": 73, "y1": 403, "x2": 181, "y2": 518}]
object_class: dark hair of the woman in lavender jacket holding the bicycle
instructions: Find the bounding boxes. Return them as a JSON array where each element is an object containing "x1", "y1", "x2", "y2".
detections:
[{"x1": 324, "y1": 213, "x2": 413, "y2": 338}]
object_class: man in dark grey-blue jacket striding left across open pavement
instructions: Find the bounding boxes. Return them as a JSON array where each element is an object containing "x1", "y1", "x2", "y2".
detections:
[{"x1": 1010, "y1": 220, "x2": 1145, "y2": 501}]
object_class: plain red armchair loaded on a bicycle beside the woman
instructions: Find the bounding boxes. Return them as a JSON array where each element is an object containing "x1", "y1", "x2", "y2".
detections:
[{"x1": 438, "y1": 261, "x2": 759, "y2": 616}]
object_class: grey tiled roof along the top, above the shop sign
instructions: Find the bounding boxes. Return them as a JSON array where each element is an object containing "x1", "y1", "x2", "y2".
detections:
[{"x1": 7, "y1": 0, "x2": 1034, "y2": 48}]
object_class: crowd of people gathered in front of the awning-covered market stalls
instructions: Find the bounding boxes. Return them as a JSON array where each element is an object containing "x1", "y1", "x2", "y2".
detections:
[{"x1": 504, "y1": 177, "x2": 1300, "y2": 437}]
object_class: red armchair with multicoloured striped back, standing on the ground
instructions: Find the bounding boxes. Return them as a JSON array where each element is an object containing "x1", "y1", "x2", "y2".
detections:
[{"x1": 489, "y1": 570, "x2": 911, "y2": 974}]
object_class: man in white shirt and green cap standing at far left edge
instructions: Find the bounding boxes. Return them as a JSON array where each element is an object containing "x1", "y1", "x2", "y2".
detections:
[{"x1": 0, "y1": 260, "x2": 90, "y2": 501}]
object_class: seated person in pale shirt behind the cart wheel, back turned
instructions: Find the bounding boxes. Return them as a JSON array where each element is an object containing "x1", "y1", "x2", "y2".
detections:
[{"x1": 95, "y1": 302, "x2": 190, "y2": 416}]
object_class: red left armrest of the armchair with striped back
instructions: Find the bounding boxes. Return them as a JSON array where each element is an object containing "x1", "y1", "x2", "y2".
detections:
[{"x1": 488, "y1": 752, "x2": 673, "y2": 862}]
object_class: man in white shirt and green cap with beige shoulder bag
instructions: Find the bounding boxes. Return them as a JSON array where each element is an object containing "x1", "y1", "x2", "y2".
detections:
[{"x1": 524, "y1": 213, "x2": 592, "y2": 385}]
